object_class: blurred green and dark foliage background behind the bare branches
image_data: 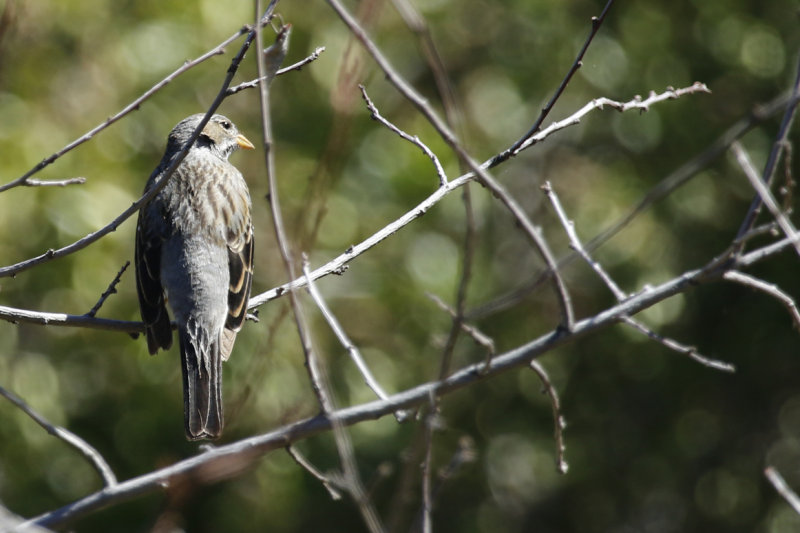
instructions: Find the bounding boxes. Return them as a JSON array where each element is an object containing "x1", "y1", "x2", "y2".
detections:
[{"x1": 0, "y1": 0, "x2": 800, "y2": 533}]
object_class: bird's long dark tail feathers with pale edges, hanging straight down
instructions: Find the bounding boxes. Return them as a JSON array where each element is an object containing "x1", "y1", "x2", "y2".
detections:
[{"x1": 178, "y1": 327, "x2": 223, "y2": 440}]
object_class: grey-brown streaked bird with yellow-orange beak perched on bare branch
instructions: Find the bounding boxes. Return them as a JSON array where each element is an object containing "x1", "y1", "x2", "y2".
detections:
[{"x1": 136, "y1": 114, "x2": 253, "y2": 440}]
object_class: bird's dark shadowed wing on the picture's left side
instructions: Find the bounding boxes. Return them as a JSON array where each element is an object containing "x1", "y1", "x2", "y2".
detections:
[{"x1": 136, "y1": 204, "x2": 172, "y2": 354}]
